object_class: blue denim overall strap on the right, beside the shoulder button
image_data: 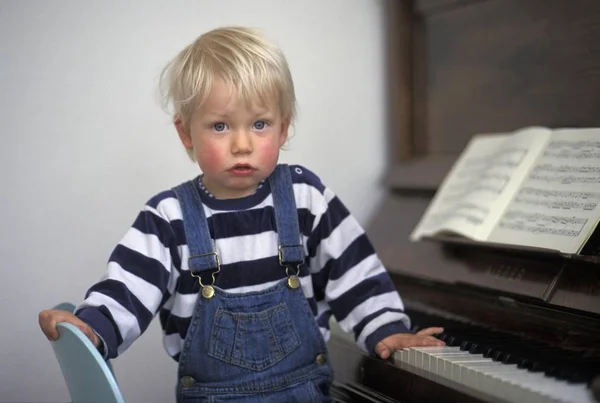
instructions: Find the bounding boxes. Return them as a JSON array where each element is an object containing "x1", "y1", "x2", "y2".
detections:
[{"x1": 269, "y1": 164, "x2": 304, "y2": 266}]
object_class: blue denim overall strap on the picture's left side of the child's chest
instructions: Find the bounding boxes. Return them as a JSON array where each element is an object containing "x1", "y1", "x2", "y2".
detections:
[{"x1": 173, "y1": 180, "x2": 220, "y2": 275}]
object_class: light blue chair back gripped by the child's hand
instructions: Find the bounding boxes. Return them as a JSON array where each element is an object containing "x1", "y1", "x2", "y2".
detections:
[{"x1": 51, "y1": 303, "x2": 124, "y2": 403}]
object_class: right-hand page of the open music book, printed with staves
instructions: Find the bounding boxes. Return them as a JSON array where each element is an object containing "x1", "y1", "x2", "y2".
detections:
[{"x1": 489, "y1": 129, "x2": 600, "y2": 253}]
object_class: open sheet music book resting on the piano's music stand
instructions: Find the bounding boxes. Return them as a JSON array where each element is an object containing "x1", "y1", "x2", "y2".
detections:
[{"x1": 410, "y1": 127, "x2": 600, "y2": 254}]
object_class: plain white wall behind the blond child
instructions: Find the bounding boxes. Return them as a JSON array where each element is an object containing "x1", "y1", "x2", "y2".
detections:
[{"x1": 0, "y1": 0, "x2": 386, "y2": 403}]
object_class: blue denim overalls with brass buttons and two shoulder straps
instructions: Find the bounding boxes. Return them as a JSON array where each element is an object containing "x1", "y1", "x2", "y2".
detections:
[{"x1": 174, "y1": 164, "x2": 333, "y2": 403}]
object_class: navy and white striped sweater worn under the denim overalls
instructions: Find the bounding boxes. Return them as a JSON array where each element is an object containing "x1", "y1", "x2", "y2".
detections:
[{"x1": 76, "y1": 165, "x2": 410, "y2": 360}]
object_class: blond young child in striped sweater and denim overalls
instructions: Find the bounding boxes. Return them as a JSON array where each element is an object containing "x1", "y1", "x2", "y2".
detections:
[{"x1": 39, "y1": 27, "x2": 443, "y2": 402}]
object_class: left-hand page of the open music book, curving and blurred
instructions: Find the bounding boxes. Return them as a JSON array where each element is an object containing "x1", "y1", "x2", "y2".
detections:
[{"x1": 411, "y1": 127, "x2": 550, "y2": 241}]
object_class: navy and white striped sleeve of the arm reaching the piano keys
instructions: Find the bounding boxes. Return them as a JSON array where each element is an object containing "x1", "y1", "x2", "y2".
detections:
[{"x1": 308, "y1": 170, "x2": 410, "y2": 355}]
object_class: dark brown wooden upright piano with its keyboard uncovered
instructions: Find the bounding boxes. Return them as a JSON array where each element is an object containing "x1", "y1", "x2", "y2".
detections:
[{"x1": 329, "y1": 0, "x2": 600, "y2": 403}]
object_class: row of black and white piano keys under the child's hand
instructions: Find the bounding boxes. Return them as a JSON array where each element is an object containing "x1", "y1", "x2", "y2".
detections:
[{"x1": 394, "y1": 310, "x2": 600, "y2": 403}]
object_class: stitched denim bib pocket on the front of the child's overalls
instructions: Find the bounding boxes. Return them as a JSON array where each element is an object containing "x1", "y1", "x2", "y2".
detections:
[{"x1": 208, "y1": 303, "x2": 300, "y2": 371}]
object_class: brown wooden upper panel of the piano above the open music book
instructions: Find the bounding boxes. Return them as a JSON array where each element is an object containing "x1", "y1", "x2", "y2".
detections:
[{"x1": 411, "y1": 0, "x2": 600, "y2": 158}]
